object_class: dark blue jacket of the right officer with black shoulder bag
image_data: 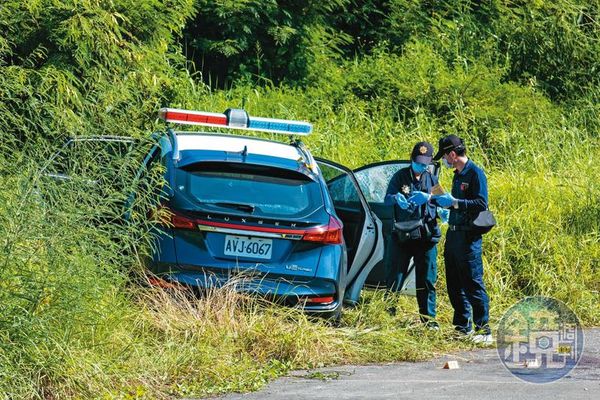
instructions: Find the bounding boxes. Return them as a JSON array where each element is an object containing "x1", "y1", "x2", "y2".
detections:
[{"x1": 448, "y1": 160, "x2": 488, "y2": 226}]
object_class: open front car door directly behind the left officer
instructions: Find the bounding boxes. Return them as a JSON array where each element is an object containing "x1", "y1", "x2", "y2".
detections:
[{"x1": 353, "y1": 160, "x2": 439, "y2": 296}]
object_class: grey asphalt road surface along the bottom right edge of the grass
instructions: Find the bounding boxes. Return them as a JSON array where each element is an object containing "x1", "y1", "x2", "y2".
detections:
[{"x1": 214, "y1": 328, "x2": 600, "y2": 400}]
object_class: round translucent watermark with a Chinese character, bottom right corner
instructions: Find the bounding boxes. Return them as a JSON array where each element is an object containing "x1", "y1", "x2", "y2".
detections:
[{"x1": 496, "y1": 296, "x2": 583, "y2": 383}]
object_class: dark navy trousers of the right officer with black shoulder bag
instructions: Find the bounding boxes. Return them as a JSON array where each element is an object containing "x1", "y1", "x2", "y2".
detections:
[{"x1": 444, "y1": 231, "x2": 490, "y2": 333}]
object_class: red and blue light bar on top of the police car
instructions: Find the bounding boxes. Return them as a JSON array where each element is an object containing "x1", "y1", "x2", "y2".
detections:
[{"x1": 158, "y1": 108, "x2": 312, "y2": 136}]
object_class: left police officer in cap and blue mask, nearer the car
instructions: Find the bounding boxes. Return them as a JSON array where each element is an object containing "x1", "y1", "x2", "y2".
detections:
[{"x1": 385, "y1": 142, "x2": 441, "y2": 329}]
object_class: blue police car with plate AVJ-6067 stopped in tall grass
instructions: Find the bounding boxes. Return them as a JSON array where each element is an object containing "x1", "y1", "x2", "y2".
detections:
[{"x1": 143, "y1": 109, "x2": 384, "y2": 315}]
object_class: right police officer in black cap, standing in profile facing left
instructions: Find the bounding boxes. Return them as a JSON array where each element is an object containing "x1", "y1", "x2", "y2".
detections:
[{"x1": 433, "y1": 135, "x2": 492, "y2": 343}]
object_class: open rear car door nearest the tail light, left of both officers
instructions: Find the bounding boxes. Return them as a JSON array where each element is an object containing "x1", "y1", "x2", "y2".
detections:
[{"x1": 316, "y1": 158, "x2": 384, "y2": 303}]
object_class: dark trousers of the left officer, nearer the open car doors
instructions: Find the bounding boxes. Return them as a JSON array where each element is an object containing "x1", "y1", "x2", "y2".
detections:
[{"x1": 387, "y1": 239, "x2": 437, "y2": 322}]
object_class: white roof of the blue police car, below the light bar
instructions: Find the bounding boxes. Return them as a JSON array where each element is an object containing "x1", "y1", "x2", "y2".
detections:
[{"x1": 177, "y1": 132, "x2": 302, "y2": 161}]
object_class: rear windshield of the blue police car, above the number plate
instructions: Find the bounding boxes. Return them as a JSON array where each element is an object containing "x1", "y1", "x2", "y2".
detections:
[{"x1": 176, "y1": 162, "x2": 323, "y2": 218}]
